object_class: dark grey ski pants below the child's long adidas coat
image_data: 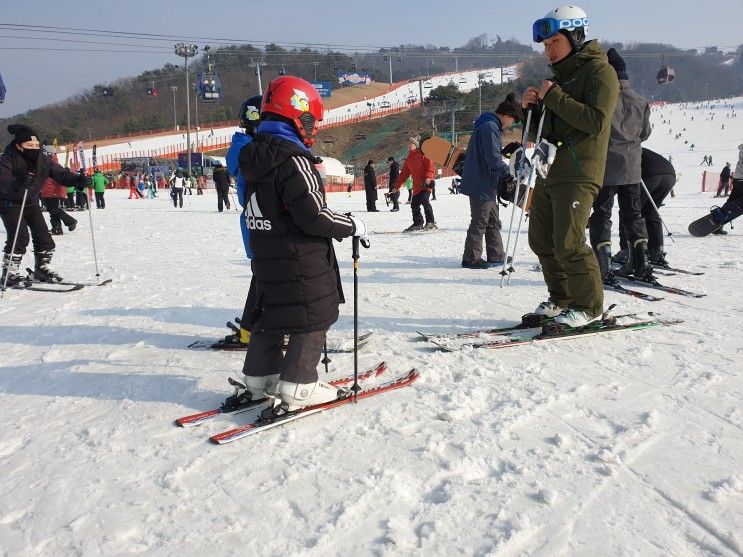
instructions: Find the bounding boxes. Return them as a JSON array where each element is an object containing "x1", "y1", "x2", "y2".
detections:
[{"x1": 243, "y1": 329, "x2": 328, "y2": 385}]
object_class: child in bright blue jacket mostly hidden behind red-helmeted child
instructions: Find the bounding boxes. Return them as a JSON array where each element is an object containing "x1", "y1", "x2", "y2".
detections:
[{"x1": 225, "y1": 95, "x2": 263, "y2": 344}]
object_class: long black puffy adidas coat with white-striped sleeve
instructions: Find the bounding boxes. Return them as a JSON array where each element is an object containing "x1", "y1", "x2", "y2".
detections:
[{"x1": 239, "y1": 134, "x2": 354, "y2": 333}]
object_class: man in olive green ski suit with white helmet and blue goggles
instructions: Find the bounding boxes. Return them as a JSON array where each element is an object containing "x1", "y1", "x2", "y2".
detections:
[{"x1": 521, "y1": 6, "x2": 619, "y2": 327}]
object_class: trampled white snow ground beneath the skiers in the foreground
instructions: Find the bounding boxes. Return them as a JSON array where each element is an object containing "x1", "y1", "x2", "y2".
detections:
[{"x1": 0, "y1": 98, "x2": 743, "y2": 556}]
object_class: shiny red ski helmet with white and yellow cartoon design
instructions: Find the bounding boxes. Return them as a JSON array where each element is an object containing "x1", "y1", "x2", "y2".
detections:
[{"x1": 261, "y1": 75, "x2": 323, "y2": 147}]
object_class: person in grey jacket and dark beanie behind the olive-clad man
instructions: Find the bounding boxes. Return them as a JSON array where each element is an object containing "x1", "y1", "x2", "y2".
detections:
[{"x1": 588, "y1": 48, "x2": 662, "y2": 280}]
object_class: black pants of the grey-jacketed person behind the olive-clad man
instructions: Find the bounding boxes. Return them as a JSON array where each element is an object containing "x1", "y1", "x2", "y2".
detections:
[{"x1": 588, "y1": 184, "x2": 648, "y2": 249}]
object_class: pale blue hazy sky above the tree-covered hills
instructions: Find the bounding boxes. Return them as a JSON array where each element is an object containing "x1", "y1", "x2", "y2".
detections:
[{"x1": 0, "y1": 0, "x2": 743, "y2": 116}]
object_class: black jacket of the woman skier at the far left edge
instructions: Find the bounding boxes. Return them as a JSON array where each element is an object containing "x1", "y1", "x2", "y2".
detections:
[{"x1": 0, "y1": 143, "x2": 83, "y2": 206}]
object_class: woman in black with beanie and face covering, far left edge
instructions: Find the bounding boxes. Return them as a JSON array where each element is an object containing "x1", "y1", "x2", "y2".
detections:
[{"x1": 0, "y1": 124, "x2": 89, "y2": 288}]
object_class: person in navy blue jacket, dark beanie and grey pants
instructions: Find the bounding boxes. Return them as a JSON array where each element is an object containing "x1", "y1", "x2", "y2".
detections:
[{"x1": 459, "y1": 93, "x2": 523, "y2": 269}]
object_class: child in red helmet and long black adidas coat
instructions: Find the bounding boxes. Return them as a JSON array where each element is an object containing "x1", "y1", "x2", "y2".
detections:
[{"x1": 239, "y1": 76, "x2": 366, "y2": 412}]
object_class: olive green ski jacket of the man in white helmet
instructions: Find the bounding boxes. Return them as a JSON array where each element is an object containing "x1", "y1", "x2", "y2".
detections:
[{"x1": 530, "y1": 40, "x2": 619, "y2": 186}]
